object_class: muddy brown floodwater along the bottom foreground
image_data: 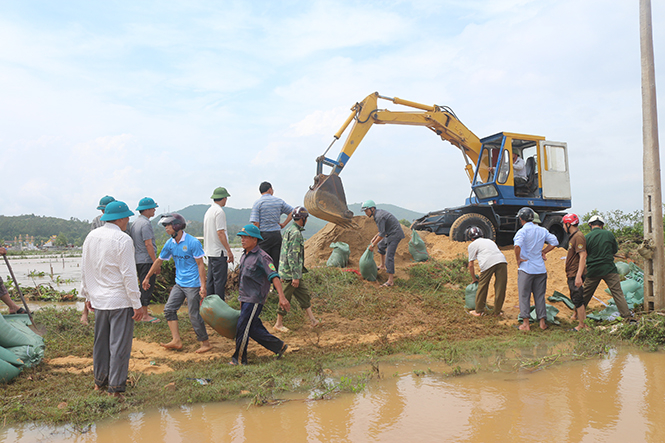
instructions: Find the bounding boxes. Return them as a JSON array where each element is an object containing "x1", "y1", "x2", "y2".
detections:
[{"x1": 0, "y1": 351, "x2": 665, "y2": 443}]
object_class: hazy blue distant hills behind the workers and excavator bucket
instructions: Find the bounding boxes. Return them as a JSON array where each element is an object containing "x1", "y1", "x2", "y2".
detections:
[{"x1": 169, "y1": 203, "x2": 425, "y2": 239}]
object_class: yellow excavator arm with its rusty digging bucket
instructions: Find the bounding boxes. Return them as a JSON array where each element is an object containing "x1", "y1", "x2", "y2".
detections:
[{"x1": 305, "y1": 92, "x2": 482, "y2": 225}]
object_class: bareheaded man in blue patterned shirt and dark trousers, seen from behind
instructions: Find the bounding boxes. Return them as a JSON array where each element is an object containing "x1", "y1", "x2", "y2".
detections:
[{"x1": 249, "y1": 182, "x2": 293, "y2": 266}]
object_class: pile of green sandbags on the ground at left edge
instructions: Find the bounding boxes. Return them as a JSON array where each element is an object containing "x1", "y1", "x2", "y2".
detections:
[{"x1": 0, "y1": 314, "x2": 44, "y2": 383}]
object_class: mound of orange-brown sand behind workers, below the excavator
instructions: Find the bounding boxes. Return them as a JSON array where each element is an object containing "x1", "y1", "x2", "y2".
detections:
[{"x1": 305, "y1": 221, "x2": 611, "y2": 318}]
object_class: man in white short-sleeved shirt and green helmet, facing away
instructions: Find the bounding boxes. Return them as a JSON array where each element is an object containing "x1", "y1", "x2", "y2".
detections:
[{"x1": 203, "y1": 187, "x2": 233, "y2": 300}]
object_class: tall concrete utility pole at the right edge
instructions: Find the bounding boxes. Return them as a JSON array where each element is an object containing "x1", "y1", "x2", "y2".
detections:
[{"x1": 640, "y1": 0, "x2": 665, "y2": 312}]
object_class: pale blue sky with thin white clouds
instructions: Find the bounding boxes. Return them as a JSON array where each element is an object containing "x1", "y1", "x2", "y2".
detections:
[{"x1": 0, "y1": 0, "x2": 665, "y2": 220}]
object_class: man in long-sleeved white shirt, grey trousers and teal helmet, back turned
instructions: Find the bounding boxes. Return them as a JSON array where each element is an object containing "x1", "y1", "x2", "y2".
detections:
[{"x1": 81, "y1": 201, "x2": 143, "y2": 397}]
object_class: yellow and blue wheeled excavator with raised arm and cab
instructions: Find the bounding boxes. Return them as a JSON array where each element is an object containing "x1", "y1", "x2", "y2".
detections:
[{"x1": 305, "y1": 92, "x2": 571, "y2": 247}]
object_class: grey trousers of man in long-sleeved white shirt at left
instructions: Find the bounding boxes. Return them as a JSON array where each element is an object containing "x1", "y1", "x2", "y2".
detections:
[{"x1": 92, "y1": 308, "x2": 134, "y2": 393}]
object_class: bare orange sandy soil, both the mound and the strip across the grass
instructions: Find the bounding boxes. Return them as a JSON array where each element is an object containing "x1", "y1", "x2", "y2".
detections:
[{"x1": 47, "y1": 217, "x2": 610, "y2": 374}]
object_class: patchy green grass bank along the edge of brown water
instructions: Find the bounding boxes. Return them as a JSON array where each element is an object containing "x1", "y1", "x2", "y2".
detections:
[{"x1": 0, "y1": 259, "x2": 648, "y2": 427}]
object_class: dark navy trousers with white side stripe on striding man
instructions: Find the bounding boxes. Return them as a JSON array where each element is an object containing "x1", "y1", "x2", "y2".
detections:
[{"x1": 233, "y1": 302, "x2": 284, "y2": 364}]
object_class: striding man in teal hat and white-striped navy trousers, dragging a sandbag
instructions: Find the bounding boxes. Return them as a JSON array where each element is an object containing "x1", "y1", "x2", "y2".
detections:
[{"x1": 229, "y1": 224, "x2": 291, "y2": 366}]
